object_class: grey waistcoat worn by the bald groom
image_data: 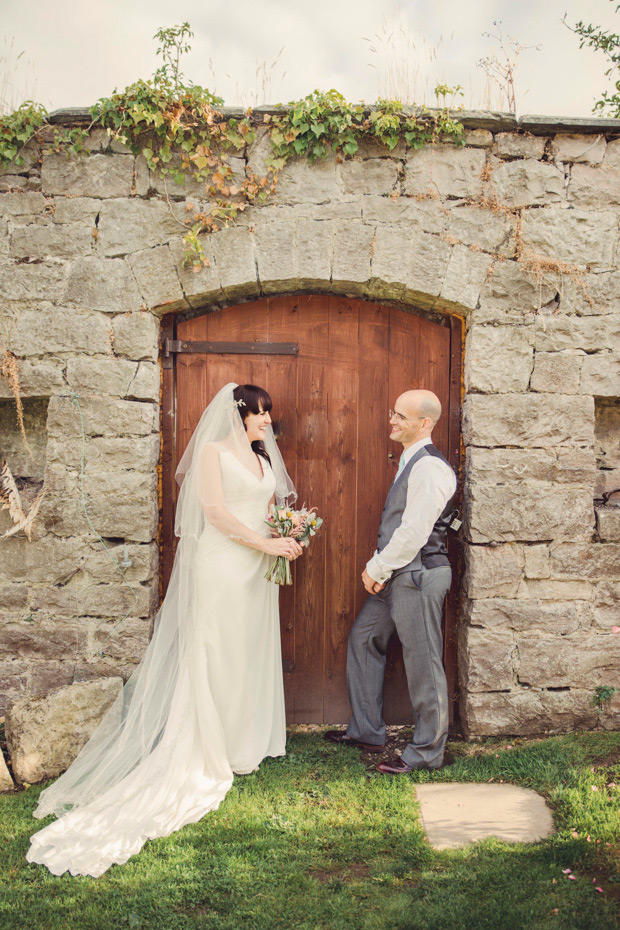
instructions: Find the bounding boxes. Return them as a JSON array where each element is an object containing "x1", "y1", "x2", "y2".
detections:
[{"x1": 377, "y1": 445, "x2": 452, "y2": 577}]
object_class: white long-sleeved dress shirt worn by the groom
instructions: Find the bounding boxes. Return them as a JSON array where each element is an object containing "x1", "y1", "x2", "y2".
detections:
[{"x1": 366, "y1": 436, "x2": 456, "y2": 584}]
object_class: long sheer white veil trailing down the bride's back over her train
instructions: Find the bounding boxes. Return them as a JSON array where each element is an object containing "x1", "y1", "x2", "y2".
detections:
[{"x1": 27, "y1": 383, "x2": 295, "y2": 876}]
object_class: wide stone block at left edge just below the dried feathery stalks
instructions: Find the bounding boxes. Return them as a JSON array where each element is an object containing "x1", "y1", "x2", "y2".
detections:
[{"x1": 0, "y1": 536, "x2": 84, "y2": 584}]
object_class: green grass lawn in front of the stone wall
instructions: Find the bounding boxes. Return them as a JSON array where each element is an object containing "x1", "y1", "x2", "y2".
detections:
[{"x1": 0, "y1": 731, "x2": 620, "y2": 930}]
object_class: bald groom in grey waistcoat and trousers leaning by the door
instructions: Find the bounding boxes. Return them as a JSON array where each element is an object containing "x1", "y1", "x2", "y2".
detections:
[{"x1": 325, "y1": 390, "x2": 456, "y2": 775}]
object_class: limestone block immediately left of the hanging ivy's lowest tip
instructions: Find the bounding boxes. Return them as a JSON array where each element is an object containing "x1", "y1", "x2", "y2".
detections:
[{"x1": 97, "y1": 199, "x2": 186, "y2": 255}]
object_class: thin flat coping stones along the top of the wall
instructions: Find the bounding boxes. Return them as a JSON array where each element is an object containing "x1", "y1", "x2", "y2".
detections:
[{"x1": 48, "y1": 104, "x2": 620, "y2": 135}]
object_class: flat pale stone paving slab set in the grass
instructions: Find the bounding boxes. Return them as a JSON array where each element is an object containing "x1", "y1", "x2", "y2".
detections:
[{"x1": 416, "y1": 782, "x2": 553, "y2": 849}]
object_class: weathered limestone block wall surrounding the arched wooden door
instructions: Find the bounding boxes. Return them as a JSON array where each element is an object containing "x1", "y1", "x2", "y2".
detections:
[{"x1": 0, "y1": 115, "x2": 620, "y2": 736}]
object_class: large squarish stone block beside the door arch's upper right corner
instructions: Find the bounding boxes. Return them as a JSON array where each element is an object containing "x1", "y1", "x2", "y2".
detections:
[{"x1": 465, "y1": 322, "x2": 534, "y2": 394}]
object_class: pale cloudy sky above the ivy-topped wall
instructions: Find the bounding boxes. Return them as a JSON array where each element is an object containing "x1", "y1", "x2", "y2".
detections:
[{"x1": 0, "y1": 0, "x2": 620, "y2": 116}]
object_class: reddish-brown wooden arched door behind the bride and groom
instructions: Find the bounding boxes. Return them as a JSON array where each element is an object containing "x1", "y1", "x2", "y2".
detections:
[{"x1": 162, "y1": 295, "x2": 461, "y2": 723}]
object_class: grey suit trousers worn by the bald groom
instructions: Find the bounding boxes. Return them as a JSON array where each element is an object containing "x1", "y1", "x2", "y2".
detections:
[{"x1": 347, "y1": 565, "x2": 452, "y2": 768}]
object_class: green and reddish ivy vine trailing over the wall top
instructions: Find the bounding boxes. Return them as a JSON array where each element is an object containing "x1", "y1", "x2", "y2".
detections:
[{"x1": 0, "y1": 22, "x2": 465, "y2": 271}]
